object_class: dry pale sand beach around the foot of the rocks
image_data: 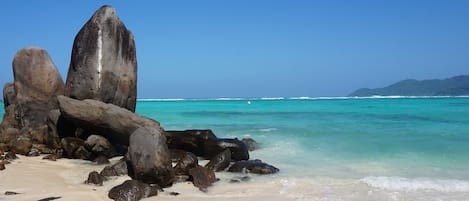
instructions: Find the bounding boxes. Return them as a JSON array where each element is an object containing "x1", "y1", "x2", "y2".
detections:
[{"x1": 0, "y1": 156, "x2": 293, "y2": 201}]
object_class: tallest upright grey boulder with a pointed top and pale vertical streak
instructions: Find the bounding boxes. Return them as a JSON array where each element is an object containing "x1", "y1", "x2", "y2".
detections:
[{"x1": 65, "y1": 6, "x2": 137, "y2": 112}]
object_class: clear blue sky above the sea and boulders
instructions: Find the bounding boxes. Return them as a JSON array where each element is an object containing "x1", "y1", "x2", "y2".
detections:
[{"x1": 0, "y1": 0, "x2": 469, "y2": 98}]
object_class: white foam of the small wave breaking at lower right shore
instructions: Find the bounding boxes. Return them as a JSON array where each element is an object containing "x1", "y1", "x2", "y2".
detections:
[{"x1": 360, "y1": 176, "x2": 469, "y2": 193}]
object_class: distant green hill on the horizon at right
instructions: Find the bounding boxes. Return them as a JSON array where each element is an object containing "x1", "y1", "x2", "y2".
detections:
[{"x1": 349, "y1": 75, "x2": 469, "y2": 96}]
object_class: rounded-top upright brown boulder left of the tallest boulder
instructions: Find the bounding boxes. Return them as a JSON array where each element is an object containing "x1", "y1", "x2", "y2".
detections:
[{"x1": 9, "y1": 47, "x2": 64, "y2": 134}]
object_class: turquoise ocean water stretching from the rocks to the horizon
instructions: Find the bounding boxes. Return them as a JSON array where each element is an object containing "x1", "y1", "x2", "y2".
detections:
[{"x1": 0, "y1": 98, "x2": 469, "y2": 200}]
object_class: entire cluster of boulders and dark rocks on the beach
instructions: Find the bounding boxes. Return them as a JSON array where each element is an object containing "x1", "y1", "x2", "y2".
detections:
[{"x1": 0, "y1": 6, "x2": 278, "y2": 200}]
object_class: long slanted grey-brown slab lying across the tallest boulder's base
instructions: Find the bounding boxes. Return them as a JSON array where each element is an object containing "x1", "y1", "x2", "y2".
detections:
[{"x1": 57, "y1": 96, "x2": 160, "y2": 145}]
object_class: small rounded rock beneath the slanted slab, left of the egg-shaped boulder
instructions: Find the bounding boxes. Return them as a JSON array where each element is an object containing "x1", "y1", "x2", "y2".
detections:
[{"x1": 85, "y1": 135, "x2": 116, "y2": 158}]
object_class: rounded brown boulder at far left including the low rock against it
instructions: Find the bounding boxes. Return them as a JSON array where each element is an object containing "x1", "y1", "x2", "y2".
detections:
[{"x1": 0, "y1": 47, "x2": 65, "y2": 148}]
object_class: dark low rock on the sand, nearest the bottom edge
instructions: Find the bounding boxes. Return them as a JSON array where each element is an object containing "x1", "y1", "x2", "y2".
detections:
[{"x1": 108, "y1": 180, "x2": 159, "y2": 201}]
